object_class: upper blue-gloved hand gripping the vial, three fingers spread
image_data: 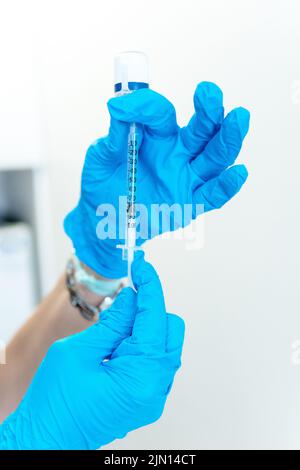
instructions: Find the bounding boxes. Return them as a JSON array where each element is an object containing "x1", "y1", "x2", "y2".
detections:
[{"x1": 65, "y1": 82, "x2": 249, "y2": 278}]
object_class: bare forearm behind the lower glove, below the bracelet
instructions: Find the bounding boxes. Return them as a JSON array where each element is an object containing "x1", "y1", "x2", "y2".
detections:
[{"x1": 0, "y1": 276, "x2": 100, "y2": 422}]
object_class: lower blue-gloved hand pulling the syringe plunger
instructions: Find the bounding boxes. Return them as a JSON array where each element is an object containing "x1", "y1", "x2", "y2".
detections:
[{"x1": 0, "y1": 259, "x2": 184, "y2": 449}]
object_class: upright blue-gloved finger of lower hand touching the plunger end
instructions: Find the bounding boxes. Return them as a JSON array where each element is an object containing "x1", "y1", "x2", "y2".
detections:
[{"x1": 131, "y1": 257, "x2": 167, "y2": 352}]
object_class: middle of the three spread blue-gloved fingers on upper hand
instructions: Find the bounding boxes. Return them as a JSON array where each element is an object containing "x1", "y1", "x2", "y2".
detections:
[{"x1": 191, "y1": 108, "x2": 250, "y2": 181}]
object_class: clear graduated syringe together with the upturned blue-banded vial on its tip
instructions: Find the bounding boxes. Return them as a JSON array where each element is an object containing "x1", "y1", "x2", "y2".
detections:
[{"x1": 115, "y1": 51, "x2": 149, "y2": 287}]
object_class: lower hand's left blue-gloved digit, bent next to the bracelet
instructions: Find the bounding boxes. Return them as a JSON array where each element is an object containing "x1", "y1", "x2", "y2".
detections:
[{"x1": 71, "y1": 287, "x2": 136, "y2": 361}]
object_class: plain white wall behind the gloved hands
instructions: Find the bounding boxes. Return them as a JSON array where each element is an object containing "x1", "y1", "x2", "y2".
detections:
[{"x1": 1, "y1": 0, "x2": 300, "y2": 449}]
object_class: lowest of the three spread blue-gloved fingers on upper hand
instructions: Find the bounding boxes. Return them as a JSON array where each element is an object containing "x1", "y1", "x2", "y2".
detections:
[{"x1": 194, "y1": 165, "x2": 248, "y2": 212}]
